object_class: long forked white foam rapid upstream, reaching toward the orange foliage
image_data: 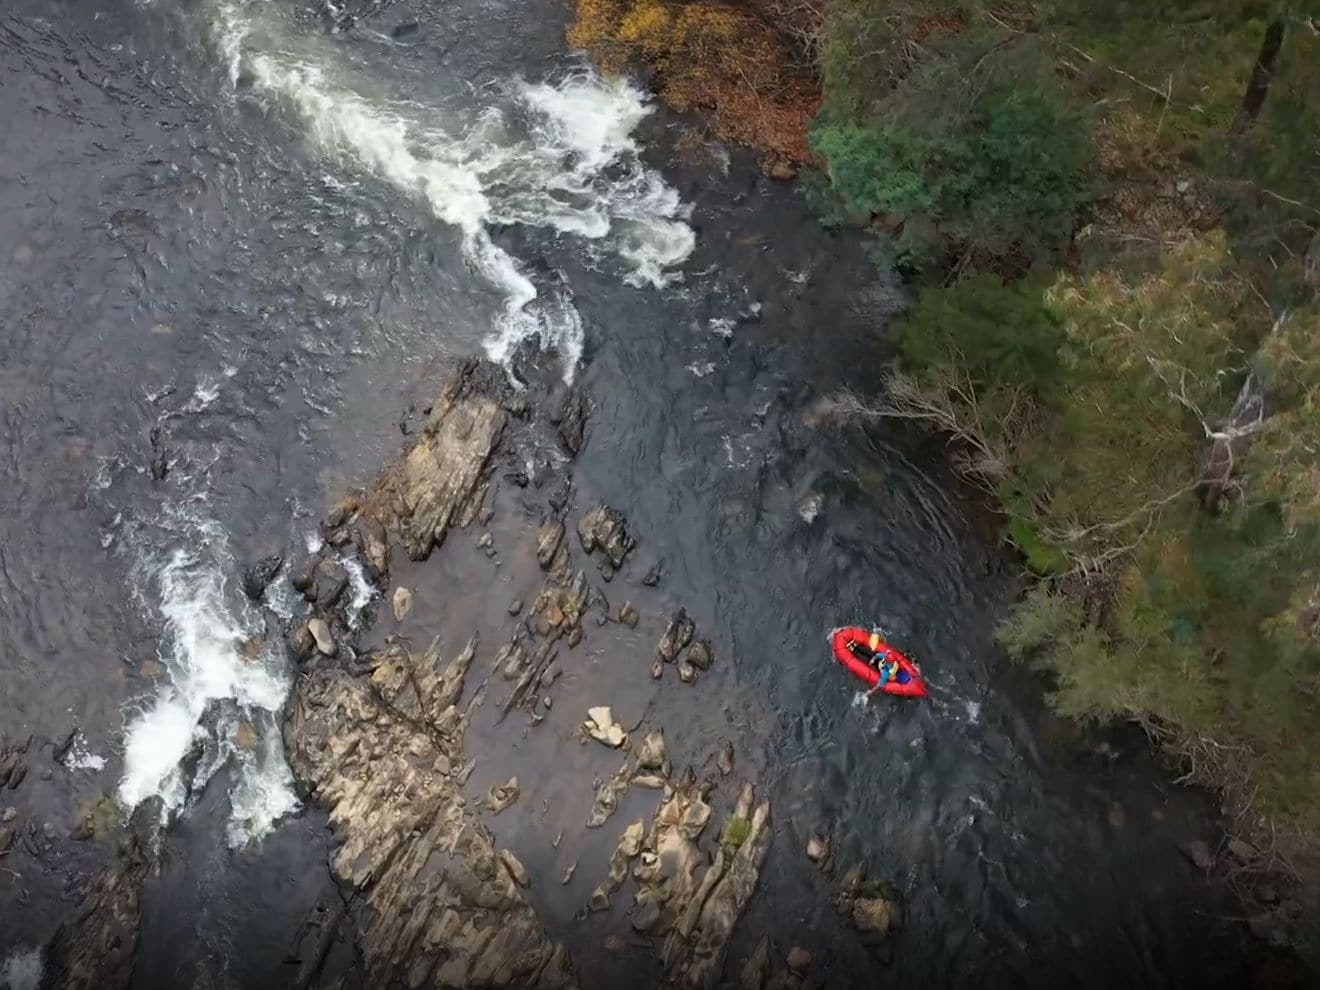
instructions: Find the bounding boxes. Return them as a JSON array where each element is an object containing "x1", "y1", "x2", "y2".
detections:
[{"x1": 218, "y1": 3, "x2": 696, "y2": 380}]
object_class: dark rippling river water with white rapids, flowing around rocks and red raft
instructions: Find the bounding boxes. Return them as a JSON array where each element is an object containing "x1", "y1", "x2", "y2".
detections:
[{"x1": 0, "y1": 0, "x2": 1261, "y2": 987}]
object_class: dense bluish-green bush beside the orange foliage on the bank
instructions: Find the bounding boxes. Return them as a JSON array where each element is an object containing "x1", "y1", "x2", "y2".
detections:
[{"x1": 813, "y1": 45, "x2": 1094, "y2": 273}]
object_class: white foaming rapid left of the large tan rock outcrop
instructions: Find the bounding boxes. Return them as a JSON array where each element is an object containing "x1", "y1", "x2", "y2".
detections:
[{"x1": 117, "y1": 510, "x2": 297, "y2": 842}]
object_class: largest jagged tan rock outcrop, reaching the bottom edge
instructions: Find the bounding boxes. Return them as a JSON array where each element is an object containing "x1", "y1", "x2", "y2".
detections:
[{"x1": 289, "y1": 643, "x2": 577, "y2": 987}]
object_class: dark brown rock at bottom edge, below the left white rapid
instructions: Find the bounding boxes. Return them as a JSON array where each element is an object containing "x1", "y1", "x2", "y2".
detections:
[{"x1": 44, "y1": 836, "x2": 147, "y2": 990}]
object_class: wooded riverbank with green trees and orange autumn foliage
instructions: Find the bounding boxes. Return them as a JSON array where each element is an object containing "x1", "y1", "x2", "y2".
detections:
[{"x1": 569, "y1": 1, "x2": 1320, "y2": 971}]
